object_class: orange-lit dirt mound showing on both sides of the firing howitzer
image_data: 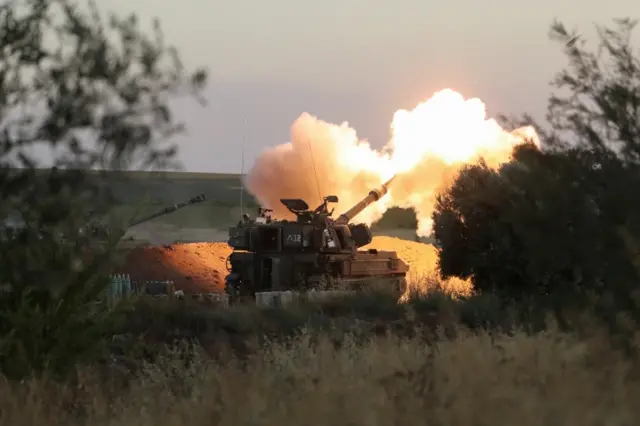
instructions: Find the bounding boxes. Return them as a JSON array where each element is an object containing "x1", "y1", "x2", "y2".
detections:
[{"x1": 120, "y1": 236, "x2": 470, "y2": 293}]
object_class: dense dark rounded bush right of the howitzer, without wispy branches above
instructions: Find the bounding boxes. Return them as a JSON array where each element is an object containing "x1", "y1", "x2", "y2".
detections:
[{"x1": 434, "y1": 145, "x2": 637, "y2": 303}]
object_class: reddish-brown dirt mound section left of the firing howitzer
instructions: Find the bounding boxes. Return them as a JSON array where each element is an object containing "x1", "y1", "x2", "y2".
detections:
[{"x1": 121, "y1": 243, "x2": 231, "y2": 293}]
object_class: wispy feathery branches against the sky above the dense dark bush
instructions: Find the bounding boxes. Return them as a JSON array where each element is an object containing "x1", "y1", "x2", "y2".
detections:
[{"x1": 547, "y1": 18, "x2": 640, "y2": 159}]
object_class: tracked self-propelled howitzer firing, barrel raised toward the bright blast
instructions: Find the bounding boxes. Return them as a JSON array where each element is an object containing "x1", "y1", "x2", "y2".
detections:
[{"x1": 225, "y1": 178, "x2": 409, "y2": 303}]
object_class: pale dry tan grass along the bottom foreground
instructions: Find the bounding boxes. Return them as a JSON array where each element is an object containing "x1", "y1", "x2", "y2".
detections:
[{"x1": 0, "y1": 324, "x2": 640, "y2": 426}]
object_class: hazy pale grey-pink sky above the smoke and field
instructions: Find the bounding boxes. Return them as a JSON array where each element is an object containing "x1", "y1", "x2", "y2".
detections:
[{"x1": 98, "y1": 0, "x2": 640, "y2": 172}]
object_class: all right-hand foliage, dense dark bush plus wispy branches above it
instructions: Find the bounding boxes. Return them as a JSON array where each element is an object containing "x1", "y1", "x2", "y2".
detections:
[{"x1": 433, "y1": 20, "x2": 640, "y2": 308}]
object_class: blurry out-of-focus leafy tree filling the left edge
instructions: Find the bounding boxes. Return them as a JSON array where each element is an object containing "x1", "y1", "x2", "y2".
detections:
[{"x1": 0, "y1": 0, "x2": 207, "y2": 378}]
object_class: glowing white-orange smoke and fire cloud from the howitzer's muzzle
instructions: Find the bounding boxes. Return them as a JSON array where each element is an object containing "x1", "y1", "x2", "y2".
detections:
[{"x1": 246, "y1": 91, "x2": 537, "y2": 236}]
